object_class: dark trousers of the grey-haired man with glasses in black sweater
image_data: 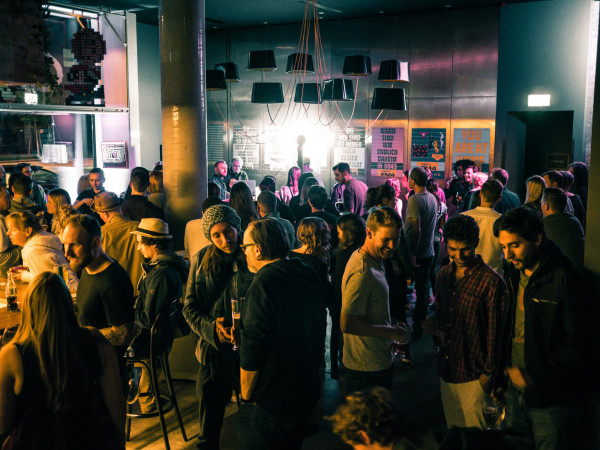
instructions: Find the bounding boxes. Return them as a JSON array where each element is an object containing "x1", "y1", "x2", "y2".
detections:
[{"x1": 237, "y1": 403, "x2": 307, "y2": 450}]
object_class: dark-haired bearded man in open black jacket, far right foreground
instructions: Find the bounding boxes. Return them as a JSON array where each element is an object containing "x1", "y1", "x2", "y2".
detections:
[{"x1": 494, "y1": 207, "x2": 583, "y2": 448}]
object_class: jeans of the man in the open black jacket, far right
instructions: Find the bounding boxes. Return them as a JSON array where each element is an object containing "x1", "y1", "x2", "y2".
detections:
[{"x1": 504, "y1": 386, "x2": 570, "y2": 450}]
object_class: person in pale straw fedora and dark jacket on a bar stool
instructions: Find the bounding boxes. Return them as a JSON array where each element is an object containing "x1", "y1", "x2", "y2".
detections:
[{"x1": 131, "y1": 219, "x2": 188, "y2": 414}]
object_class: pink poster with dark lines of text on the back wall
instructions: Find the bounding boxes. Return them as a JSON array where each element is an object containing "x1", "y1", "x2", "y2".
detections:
[{"x1": 371, "y1": 128, "x2": 404, "y2": 178}]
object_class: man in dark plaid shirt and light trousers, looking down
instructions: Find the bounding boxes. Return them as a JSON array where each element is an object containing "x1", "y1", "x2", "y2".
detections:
[{"x1": 431, "y1": 214, "x2": 506, "y2": 428}]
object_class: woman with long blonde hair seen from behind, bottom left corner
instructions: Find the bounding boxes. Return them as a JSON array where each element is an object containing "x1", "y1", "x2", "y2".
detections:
[{"x1": 0, "y1": 272, "x2": 125, "y2": 450}]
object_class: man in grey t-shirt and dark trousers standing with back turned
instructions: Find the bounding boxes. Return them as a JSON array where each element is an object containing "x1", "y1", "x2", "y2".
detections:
[{"x1": 404, "y1": 167, "x2": 438, "y2": 339}]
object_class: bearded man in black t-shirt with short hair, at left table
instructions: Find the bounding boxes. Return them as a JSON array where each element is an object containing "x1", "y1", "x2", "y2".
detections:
[{"x1": 63, "y1": 214, "x2": 134, "y2": 384}]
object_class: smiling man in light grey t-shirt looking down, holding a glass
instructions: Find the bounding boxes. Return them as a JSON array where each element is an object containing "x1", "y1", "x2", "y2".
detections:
[{"x1": 341, "y1": 207, "x2": 405, "y2": 393}]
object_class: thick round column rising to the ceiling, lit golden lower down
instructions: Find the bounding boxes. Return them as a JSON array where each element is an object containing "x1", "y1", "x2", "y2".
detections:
[{"x1": 159, "y1": 0, "x2": 207, "y2": 250}]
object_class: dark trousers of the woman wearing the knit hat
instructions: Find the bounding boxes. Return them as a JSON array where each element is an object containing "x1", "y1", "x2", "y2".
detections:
[{"x1": 196, "y1": 352, "x2": 239, "y2": 449}]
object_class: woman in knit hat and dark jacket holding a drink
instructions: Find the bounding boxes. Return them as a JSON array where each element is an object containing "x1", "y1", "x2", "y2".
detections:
[{"x1": 183, "y1": 205, "x2": 253, "y2": 449}]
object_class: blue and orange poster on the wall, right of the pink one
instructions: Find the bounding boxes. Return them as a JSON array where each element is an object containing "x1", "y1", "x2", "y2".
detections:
[{"x1": 410, "y1": 128, "x2": 446, "y2": 180}]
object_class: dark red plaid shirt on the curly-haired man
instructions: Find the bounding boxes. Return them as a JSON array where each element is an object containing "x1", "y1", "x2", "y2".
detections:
[{"x1": 435, "y1": 255, "x2": 506, "y2": 383}]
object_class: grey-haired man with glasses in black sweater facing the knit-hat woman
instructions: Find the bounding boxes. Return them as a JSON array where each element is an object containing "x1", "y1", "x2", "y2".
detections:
[{"x1": 238, "y1": 219, "x2": 323, "y2": 450}]
